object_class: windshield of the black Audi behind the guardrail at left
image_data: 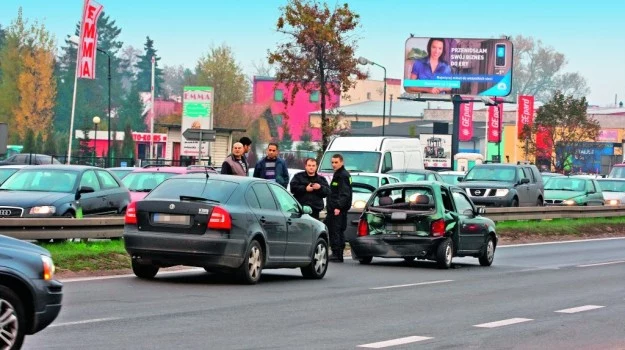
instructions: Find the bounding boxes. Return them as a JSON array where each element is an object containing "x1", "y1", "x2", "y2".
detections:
[{"x1": 0, "y1": 169, "x2": 78, "y2": 193}]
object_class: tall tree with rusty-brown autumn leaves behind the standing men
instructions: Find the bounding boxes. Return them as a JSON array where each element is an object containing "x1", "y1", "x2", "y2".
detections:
[{"x1": 269, "y1": 0, "x2": 366, "y2": 150}]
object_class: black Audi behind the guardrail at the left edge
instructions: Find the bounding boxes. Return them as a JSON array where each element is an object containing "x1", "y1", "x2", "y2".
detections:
[{"x1": 0, "y1": 165, "x2": 130, "y2": 218}]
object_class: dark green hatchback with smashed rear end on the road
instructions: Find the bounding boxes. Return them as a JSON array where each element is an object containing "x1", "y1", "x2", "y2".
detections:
[{"x1": 350, "y1": 181, "x2": 497, "y2": 268}]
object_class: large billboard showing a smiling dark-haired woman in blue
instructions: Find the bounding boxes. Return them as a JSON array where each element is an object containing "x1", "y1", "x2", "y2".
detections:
[{"x1": 404, "y1": 37, "x2": 512, "y2": 97}]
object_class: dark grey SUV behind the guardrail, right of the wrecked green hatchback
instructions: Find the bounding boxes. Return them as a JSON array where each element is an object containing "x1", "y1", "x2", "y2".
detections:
[{"x1": 458, "y1": 164, "x2": 545, "y2": 207}]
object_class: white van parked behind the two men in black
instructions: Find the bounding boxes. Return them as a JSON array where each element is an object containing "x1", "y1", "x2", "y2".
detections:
[{"x1": 319, "y1": 136, "x2": 423, "y2": 173}]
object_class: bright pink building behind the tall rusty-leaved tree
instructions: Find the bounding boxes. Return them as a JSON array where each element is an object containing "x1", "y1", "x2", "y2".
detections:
[{"x1": 253, "y1": 76, "x2": 340, "y2": 141}]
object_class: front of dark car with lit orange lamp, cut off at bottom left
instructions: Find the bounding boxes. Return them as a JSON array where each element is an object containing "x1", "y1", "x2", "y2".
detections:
[{"x1": 0, "y1": 235, "x2": 63, "y2": 349}]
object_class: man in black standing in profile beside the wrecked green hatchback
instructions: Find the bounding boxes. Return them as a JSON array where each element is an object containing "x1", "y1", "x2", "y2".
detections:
[{"x1": 325, "y1": 153, "x2": 352, "y2": 262}]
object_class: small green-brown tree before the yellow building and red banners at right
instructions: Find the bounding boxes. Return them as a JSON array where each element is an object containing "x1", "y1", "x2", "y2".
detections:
[{"x1": 520, "y1": 91, "x2": 601, "y2": 171}]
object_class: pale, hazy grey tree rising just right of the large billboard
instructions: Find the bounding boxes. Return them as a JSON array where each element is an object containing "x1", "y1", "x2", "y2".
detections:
[{"x1": 512, "y1": 35, "x2": 590, "y2": 102}]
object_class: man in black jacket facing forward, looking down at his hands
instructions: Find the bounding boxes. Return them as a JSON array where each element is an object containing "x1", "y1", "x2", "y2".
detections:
[{"x1": 291, "y1": 158, "x2": 330, "y2": 220}]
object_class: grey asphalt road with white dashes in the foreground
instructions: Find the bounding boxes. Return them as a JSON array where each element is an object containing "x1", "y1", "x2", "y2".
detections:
[{"x1": 24, "y1": 239, "x2": 625, "y2": 349}]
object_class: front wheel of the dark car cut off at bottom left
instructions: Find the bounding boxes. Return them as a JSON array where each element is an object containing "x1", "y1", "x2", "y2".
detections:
[{"x1": 0, "y1": 286, "x2": 26, "y2": 349}]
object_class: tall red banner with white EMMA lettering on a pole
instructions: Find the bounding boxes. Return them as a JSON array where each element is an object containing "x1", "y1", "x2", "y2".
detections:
[{"x1": 76, "y1": 0, "x2": 104, "y2": 79}]
